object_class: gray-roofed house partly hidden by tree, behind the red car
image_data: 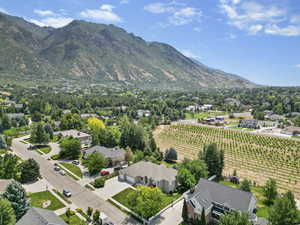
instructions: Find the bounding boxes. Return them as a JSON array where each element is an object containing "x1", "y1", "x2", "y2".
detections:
[{"x1": 83, "y1": 145, "x2": 126, "y2": 167}]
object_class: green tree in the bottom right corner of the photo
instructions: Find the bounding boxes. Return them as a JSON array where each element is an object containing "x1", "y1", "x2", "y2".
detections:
[{"x1": 269, "y1": 191, "x2": 300, "y2": 225}]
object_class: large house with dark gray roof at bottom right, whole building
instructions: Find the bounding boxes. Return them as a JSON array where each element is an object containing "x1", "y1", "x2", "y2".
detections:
[{"x1": 185, "y1": 178, "x2": 258, "y2": 224}]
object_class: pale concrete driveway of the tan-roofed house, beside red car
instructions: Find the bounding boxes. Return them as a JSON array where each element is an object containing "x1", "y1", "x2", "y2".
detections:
[{"x1": 95, "y1": 177, "x2": 131, "y2": 200}]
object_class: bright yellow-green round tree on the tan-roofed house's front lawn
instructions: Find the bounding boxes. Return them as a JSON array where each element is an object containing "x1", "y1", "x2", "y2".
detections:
[{"x1": 127, "y1": 186, "x2": 163, "y2": 219}]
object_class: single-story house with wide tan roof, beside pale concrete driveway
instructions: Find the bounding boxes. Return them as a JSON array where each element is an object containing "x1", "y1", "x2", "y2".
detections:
[{"x1": 119, "y1": 161, "x2": 177, "y2": 193}]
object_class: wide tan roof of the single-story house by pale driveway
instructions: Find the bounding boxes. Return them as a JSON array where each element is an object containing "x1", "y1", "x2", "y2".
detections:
[{"x1": 120, "y1": 161, "x2": 177, "y2": 181}]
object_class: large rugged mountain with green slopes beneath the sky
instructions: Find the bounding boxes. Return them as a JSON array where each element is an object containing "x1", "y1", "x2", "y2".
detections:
[{"x1": 0, "y1": 13, "x2": 256, "y2": 89}]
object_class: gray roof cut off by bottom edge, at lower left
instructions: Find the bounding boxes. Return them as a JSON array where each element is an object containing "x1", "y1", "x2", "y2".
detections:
[{"x1": 16, "y1": 208, "x2": 67, "y2": 225}]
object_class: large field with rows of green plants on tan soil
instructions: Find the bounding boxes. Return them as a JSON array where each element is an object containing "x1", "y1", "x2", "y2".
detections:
[{"x1": 154, "y1": 125, "x2": 300, "y2": 198}]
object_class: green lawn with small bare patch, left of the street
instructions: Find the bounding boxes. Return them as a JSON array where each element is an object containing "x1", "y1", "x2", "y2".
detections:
[{"x1": 29, "y1": 191, "x2": 65, "y2": 211}]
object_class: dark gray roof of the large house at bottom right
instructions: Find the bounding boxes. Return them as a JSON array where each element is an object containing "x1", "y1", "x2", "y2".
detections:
[{"x1": 188, "y1": 178, "x2": 255, "y2": 212}]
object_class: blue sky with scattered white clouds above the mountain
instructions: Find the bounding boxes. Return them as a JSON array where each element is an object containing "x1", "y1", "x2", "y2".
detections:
[{"x1": 0, "y1": 0, "x2": 300, "y2": 86}]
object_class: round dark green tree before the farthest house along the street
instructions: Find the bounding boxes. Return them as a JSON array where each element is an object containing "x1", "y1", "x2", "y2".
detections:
[{"x1": 59, "y1": 137, "x2": 81, "y2": 159}]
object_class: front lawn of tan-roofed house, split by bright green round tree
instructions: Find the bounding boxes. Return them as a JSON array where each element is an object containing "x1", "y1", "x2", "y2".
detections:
[{"x1": 112, "y1": 188, "x2": 181, "y2": 218}]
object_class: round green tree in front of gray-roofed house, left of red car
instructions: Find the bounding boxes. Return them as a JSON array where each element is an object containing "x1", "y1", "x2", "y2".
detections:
[{"x1": 85, "y1": 152, "x2": 107, "y2": 175}]
